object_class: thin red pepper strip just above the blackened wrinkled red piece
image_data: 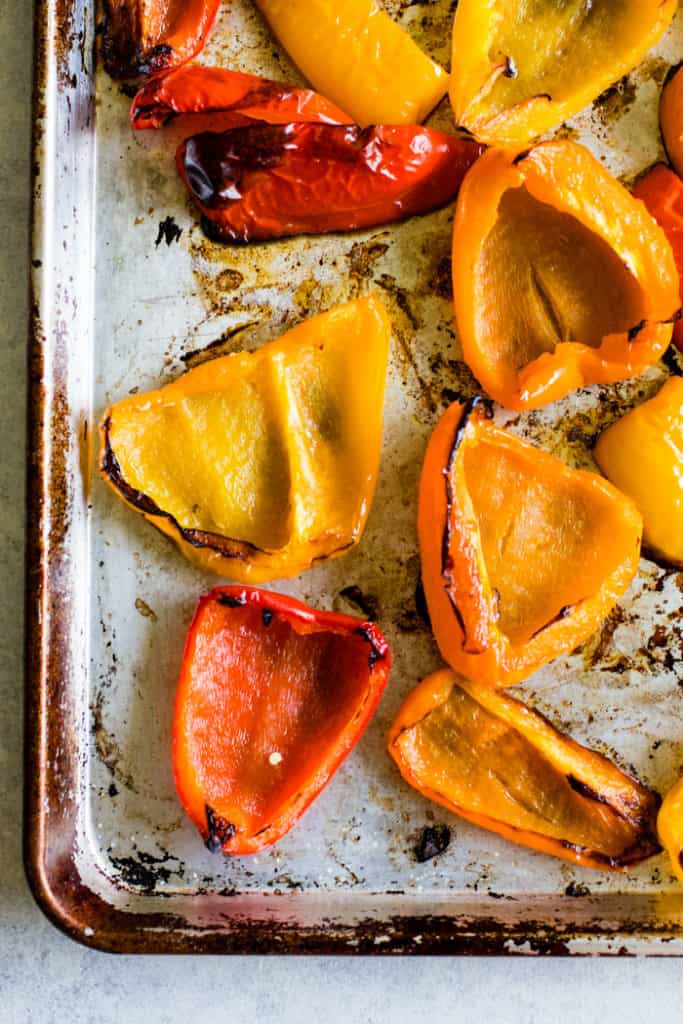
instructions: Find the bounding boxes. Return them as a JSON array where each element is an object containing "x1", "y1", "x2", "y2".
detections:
[{"x1": 130, "y1": 65, "x2": 351, "y2": 131}]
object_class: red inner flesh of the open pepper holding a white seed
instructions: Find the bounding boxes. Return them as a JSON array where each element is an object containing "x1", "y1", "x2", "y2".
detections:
[{"x1": 179, "y1": 601, "x2": 369, "y2": 835}]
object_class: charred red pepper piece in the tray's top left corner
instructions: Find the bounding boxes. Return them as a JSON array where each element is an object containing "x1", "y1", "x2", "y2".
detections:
[{"x1": 102, "y1": 0, "x2": 220, "y2": 79}]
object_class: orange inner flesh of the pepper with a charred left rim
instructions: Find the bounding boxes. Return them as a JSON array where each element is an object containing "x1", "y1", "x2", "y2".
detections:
[{"x1": 464, "y1": 438, "x2": 643, "y2": 643}]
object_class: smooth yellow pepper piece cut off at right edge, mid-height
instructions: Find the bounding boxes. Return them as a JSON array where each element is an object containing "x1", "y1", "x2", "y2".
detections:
[{"x1": 594, "y1": 377, "x2": 683, "y2": 566}]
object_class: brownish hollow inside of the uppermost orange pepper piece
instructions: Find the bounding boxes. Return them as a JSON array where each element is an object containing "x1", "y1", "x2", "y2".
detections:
[{"x1": 475, "y1": 185, "x2": 645, "y2": 371}]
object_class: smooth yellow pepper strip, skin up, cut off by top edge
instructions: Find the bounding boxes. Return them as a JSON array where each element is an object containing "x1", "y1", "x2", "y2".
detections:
[{"x1": 256, "y1": 0, "x2": 449, "y2": 125}]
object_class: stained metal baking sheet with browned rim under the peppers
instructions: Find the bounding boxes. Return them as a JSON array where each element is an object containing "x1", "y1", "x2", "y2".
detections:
[{"x1": 26, "y1": 0, "x2": 683, "y2": 954}]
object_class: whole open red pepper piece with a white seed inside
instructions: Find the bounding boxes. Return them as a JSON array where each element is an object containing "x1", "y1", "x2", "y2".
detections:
[{"x1": 173, "y1": 587, "x2": 390, "y2": 854}]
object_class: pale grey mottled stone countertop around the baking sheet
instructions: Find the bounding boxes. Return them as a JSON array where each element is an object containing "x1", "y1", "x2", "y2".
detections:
[{"x1": 0, "y1": 0, "x2": 680, "y2": 1024}]
